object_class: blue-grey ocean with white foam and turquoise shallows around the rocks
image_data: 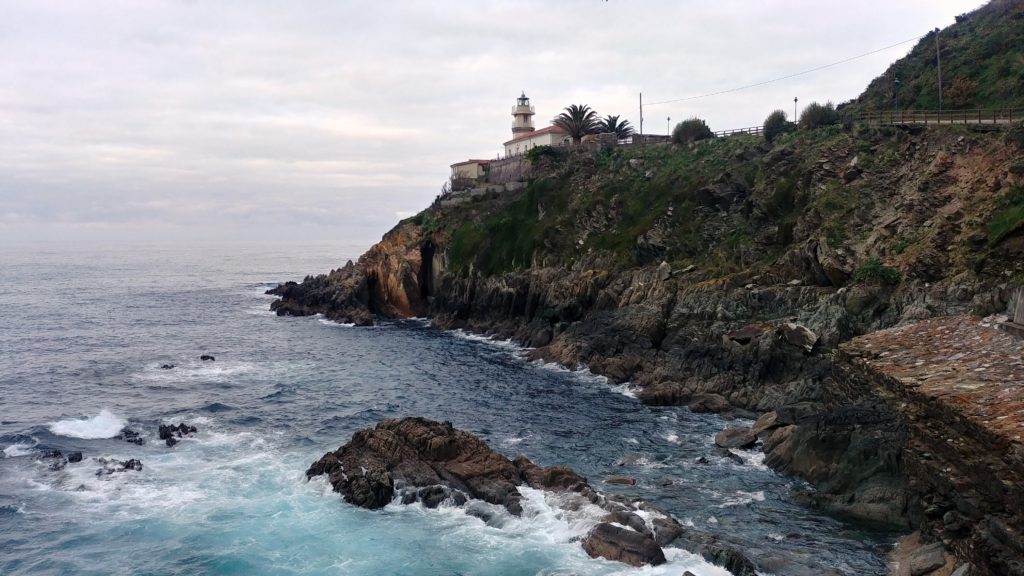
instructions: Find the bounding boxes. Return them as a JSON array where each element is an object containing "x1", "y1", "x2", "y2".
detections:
[{"x1": 0, "y1": 244, "x2": 885, "y2": 576}]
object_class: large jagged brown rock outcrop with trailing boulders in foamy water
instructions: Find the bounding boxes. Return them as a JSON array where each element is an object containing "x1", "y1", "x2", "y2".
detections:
[{"x1": 306, "y1": 418, "x2": 700, "y2": 566}]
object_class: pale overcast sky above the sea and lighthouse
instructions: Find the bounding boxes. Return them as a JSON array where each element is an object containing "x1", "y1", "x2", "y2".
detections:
[{"x1": 0, "y1": 0, "x2": 981, "y2": 245}]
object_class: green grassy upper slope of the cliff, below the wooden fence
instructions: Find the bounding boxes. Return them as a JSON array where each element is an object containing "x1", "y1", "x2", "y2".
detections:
[{"x1": 416, "y1": 121, "x2": 1024, "y2": 280}]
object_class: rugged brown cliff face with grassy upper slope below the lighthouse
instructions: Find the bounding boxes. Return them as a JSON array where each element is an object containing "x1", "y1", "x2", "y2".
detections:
[{"x1": 273, "y1": 123, "x2": 1024, "y2": 574}]
